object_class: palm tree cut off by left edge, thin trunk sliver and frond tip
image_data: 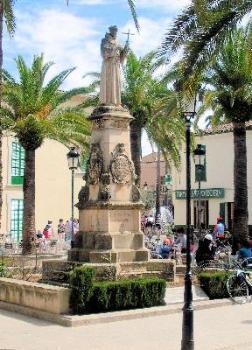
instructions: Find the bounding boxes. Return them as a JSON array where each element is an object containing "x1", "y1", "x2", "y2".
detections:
[{"x1": 0, "y1": 0, "x2": 16, "y2": 232}]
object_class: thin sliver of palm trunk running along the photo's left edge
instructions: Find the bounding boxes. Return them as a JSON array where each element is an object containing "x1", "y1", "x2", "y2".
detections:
[{"x1": 0, "y1": 0, "x2": 3, "y2": 234}]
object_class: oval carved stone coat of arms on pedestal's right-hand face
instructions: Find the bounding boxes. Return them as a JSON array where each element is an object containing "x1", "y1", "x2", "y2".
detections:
[{"x1": 110, "y1": 143, "x2": 135, "y2": 184}]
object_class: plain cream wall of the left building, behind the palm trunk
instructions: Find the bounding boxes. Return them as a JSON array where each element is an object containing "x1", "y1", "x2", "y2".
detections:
[{"x1": 1, "y1": 136, "x2": 84, "y2": 234}]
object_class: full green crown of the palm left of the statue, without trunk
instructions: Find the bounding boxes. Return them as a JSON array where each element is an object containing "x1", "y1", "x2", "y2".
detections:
[{"x1": 0, "y1": 55, "x2": 90, "y2": 154}]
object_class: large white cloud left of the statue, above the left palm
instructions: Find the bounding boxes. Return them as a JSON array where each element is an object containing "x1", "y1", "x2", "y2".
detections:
[{"x1": 14, "y1": 10, "x2": 100, "y2": 89}]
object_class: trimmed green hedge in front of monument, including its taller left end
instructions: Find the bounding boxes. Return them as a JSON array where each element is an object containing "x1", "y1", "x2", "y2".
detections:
[{"x1": 70, "y1": 267, "x2": 166, "y2": 314}]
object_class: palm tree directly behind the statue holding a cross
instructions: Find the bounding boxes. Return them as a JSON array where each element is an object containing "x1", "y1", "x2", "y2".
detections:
[{"x1": 81, "y1": 52, "x2": 184, "y2": 186}]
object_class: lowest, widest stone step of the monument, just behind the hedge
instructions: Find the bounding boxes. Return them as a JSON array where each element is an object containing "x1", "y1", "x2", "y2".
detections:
[{"x1": 42, "y1": 260, "x2": 176, "y2": 283}]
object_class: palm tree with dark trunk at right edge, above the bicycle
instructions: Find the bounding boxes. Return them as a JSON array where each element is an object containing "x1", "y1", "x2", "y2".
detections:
[{"x1": 197, "y1": 25, "x2": 252, "y2": 248}]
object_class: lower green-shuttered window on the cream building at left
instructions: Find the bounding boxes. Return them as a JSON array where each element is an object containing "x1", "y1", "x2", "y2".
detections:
[{"x1": 11, "y1": 199, "x2": 24, "y2": 242}]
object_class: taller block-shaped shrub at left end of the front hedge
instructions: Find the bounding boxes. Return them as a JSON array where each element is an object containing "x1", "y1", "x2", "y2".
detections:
[{"x1": 69, "y1": 266, "x2": 95, "y2": 314}]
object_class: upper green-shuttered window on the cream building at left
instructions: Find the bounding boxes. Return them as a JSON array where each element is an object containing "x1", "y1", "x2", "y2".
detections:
[{"x1": 11, "y1": 141, "x2": 25, "y2": 185}]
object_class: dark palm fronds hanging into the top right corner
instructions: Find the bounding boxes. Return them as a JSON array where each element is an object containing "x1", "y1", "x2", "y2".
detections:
[{"x1": 160, "y1": 0, "x2": 252, "y2": 81}]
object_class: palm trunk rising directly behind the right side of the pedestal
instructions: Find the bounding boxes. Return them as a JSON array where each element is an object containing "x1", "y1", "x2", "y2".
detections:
[{"x1": 130, "y1": 122, "x2": 142, "y2": 187}]
